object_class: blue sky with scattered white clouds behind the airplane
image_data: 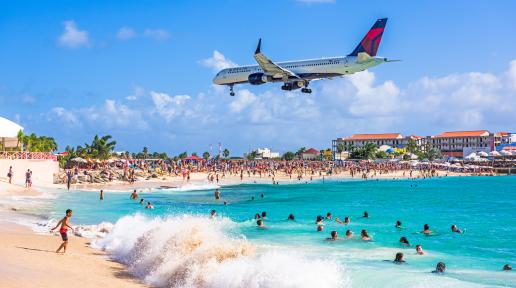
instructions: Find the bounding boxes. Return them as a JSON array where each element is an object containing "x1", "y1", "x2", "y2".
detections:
[{"x1": 0, "y1": 0, "x2": 516, "y2": 154}]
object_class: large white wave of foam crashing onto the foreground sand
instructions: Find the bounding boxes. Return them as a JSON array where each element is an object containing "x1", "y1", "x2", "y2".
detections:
[{"x1": 93, "y1": 214, "x2": 349, "y2": 288}]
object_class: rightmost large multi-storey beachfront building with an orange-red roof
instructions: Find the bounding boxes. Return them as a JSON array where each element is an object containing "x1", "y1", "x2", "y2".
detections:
[{"x1": 429, "y1": 130, "x2": 495, "y2": 157}]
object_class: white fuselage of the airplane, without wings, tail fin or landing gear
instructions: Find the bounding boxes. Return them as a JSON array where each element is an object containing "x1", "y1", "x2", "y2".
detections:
[{"x1": 213, "y1": 56, "x2": 387, "y2": 85}]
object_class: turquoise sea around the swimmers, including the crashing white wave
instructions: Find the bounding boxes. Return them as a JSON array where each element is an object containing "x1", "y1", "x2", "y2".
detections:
[{"x1": 37, "y1": 176, "x2": 516, "y2": 287}]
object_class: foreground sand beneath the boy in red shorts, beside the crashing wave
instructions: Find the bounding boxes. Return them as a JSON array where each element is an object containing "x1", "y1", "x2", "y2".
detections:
[{"x1": 0, "y1": 222, "x2": 146, "y2": 288}]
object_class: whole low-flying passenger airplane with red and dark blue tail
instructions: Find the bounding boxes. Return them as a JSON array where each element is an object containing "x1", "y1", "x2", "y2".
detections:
[{"x1": 213, "y1": 18, "x2": 399, "y2": 96}]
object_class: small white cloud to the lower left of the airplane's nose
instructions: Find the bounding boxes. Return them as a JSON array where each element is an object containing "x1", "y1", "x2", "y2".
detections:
[{"x1": 150, "y1": 91, "x2": 191, "y2": 122}]
